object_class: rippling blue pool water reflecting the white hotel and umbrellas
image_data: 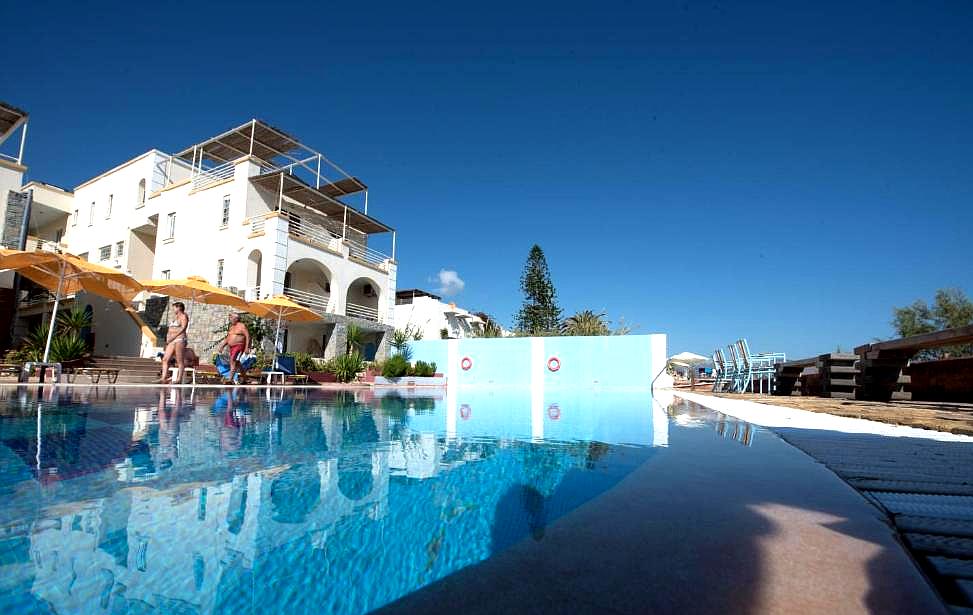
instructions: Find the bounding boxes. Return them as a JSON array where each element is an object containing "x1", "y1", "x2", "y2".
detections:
[{"x1": 0, "y1": 388, "x2": 753, "y2": 615}]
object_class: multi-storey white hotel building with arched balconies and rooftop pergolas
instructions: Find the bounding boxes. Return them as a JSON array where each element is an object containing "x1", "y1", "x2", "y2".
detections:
[{"x1": 10, "y1": 120, "x2": 396, "y2": 357}]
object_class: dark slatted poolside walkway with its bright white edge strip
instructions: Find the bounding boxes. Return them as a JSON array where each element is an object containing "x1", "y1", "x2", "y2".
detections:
[{"x1": 676, "y1": 392, "x2": 973, "y2": 608}]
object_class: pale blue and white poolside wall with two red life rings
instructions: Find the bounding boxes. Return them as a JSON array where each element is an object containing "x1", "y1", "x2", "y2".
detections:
[{"x1": 410, "y1": 333, "x2": 666, "y2": 389}]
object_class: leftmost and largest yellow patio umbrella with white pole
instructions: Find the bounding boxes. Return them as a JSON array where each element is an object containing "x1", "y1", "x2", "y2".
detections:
[{"x1": 0, "y1": 248, "x2": 142, "y2": 363}]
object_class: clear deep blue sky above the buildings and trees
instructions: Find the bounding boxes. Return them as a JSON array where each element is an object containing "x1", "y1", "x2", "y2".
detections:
[{"x1": 0, "y1": 0, "x2": 973, "y2": 355}]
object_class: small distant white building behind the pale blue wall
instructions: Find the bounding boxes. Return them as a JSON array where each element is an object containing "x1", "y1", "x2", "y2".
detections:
[{"x1": 395, "y1": 288, "x2": 494, "y2": 339}]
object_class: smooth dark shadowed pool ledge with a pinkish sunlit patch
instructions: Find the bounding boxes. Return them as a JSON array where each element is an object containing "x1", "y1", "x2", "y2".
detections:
[{"x1": 383, "y1": 400, "x2": 945, "y2": 613}]
